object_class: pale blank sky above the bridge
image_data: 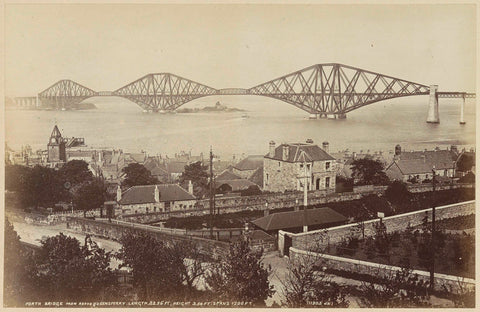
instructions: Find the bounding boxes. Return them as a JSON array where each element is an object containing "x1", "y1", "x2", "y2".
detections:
[{"x1": 5, "y1": 4, "x2": 476, "y2": 96}]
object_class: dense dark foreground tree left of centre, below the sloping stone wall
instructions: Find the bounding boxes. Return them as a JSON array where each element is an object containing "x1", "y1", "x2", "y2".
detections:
[{"x1": 117, "y1": 233, "x2": 185, "y2": 300}]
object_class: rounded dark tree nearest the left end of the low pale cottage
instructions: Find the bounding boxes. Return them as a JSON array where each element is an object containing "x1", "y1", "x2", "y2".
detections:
[{"x1": 73, "y1": 179, "x2": 107, "y2": 211}]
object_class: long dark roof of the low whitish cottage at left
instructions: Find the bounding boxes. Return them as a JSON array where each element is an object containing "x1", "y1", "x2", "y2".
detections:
[{"x1": 119, "y1": 184, "x2": 195, "y2": 205}]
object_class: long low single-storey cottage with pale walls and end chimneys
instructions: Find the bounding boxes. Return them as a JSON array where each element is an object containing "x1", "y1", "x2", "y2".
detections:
[{"x1": 117, "y1": 182, "x2": 196, "y2": 215}]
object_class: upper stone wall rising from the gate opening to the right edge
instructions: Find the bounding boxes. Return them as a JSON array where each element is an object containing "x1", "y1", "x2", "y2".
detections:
[{"x1": 286, "y1": 200, "x2": 475, "y2": 254}]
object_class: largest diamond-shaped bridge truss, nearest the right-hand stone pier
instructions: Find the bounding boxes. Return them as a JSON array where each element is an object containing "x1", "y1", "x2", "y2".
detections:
[{"x1": 249, "y1": 64, "x2": 429, "y2": 115}]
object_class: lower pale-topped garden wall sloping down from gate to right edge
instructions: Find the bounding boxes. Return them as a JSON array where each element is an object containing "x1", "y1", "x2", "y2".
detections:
[{"x1": 290, "y1": 248, "x2": 475, "y2": 293}]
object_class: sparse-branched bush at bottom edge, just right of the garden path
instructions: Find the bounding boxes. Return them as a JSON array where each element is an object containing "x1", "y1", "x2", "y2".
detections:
[{"x1": 282, "y1": 251, "x2": 348, "y2": 308}]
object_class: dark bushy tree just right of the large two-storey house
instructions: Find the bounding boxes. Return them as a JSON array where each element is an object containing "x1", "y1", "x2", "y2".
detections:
[{"x1": 352, "y1": 158, "x2": 389, "y2": 185}]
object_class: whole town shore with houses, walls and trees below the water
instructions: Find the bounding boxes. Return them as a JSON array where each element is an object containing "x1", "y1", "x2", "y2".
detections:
[{"x1": 5, "y1": 125, "x2": 475, "y2": 307}]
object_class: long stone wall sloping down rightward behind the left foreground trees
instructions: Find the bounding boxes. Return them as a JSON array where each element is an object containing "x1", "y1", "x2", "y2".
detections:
[{"x1": 67, "y1": 217, "x2": 229, "y2": 257}]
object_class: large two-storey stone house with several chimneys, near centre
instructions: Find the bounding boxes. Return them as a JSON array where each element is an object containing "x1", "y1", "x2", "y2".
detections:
[{"x1": 263, "y1": 140, "x2": 336, "y2": 192}]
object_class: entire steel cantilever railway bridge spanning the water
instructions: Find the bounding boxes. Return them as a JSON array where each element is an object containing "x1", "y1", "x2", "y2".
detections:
[{"x1": 13, "y1": 63, "x2": 475, "y2": 122}]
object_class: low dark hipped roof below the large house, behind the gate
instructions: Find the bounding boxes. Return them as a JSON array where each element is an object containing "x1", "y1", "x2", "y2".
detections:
[{"x1": 252, "y1": 207, "x2": 347, "y2": 231}]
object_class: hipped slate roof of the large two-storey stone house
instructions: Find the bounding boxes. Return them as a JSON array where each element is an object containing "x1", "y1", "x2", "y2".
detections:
[{"x1": 265, "y1": 143, "x2": 335, "y2": 162}]
